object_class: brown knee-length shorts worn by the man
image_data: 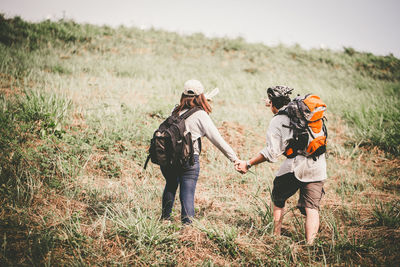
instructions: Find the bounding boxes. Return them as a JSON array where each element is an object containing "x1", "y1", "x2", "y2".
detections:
[{"x1": 272, "y1": 173, "x2": 325, "y2": 215}]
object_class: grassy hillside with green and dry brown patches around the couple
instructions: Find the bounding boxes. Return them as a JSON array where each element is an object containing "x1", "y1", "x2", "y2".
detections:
[{"x1": 0, "y1": 16, "x2": 400, "y2": 266}]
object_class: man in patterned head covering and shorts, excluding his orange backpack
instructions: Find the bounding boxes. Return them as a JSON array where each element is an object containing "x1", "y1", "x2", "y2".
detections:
[{"x1": 235, "y1": 86, "x2": 327, "y2": 244}]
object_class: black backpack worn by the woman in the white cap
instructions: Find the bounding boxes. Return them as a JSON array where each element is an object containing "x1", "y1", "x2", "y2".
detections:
[{"x1": 144, "y1": 107, "x2": 201, "y2": 169}]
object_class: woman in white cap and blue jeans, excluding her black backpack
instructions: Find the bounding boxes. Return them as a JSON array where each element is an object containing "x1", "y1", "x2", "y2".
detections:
[{"x1": 161, "y1": 80, "x2": 238, "y2": 224}]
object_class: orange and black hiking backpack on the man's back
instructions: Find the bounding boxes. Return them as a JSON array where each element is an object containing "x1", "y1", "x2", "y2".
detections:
[{"x1": 277, "y1": 94, "x2": 328, "y2": 160}]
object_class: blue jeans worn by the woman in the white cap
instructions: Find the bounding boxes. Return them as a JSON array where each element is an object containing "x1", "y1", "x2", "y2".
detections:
[{"x1": 161, "y1": 155, "x2": 200, "y2": 224}]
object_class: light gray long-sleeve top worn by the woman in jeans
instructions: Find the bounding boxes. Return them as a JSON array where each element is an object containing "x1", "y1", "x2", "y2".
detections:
[{"x1": 179, "y1": 110, "x2": 238, "y2": 162}]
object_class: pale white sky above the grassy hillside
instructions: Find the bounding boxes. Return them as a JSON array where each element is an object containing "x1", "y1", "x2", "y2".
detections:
[{"x1": 0, "y1": 0, "x2": 400, "y2": 58}]
